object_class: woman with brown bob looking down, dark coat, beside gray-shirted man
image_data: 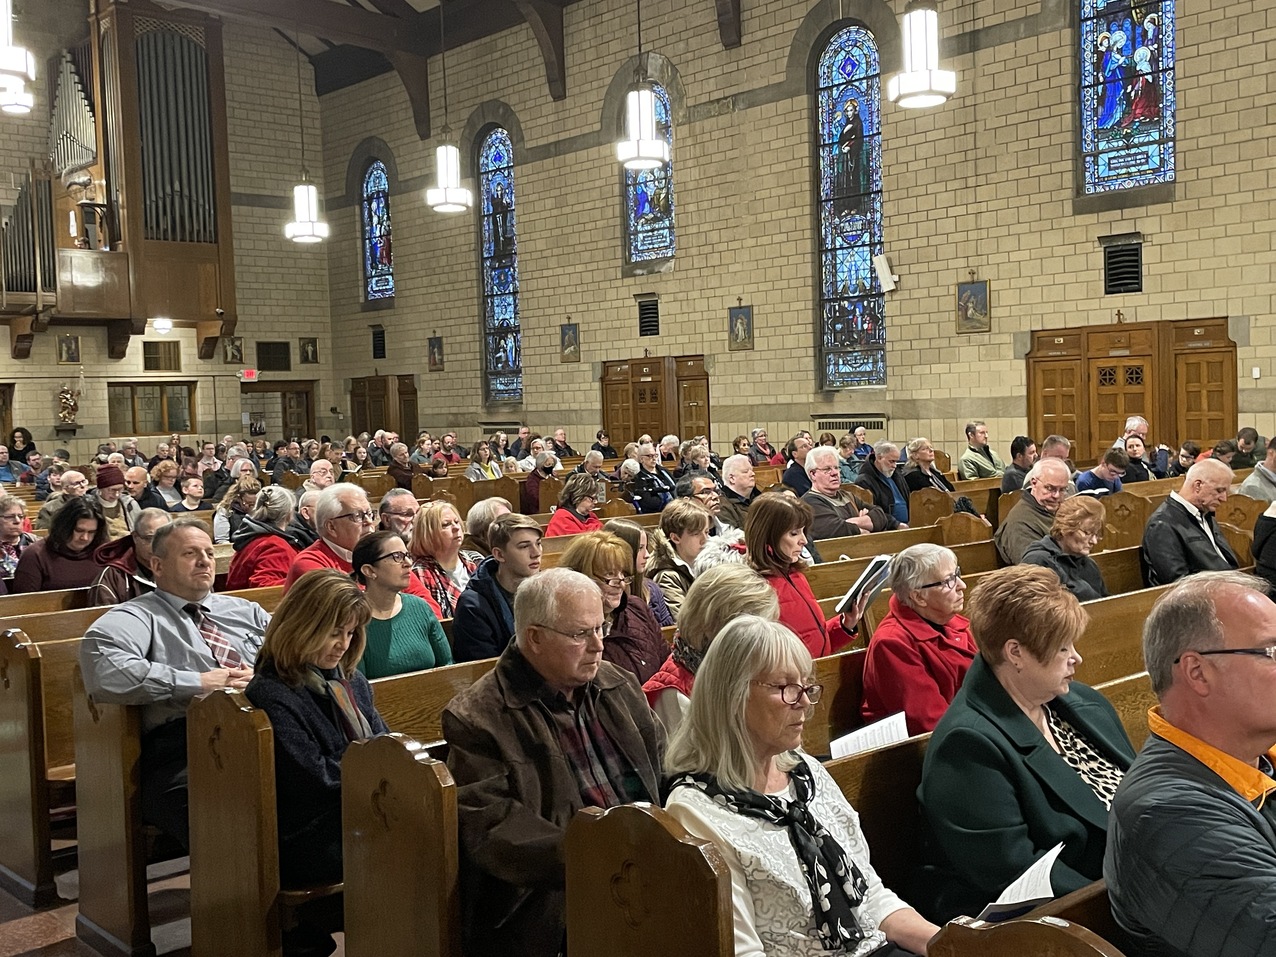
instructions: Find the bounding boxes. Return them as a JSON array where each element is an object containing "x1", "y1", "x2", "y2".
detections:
[{"x1": 244, "y1": 569, "x2": 388, "y2": 951}]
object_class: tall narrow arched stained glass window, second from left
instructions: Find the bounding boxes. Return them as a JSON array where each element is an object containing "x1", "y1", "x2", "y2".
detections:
[{"x1": 479, "y1": 126, "x2": 523, "y2": 402}]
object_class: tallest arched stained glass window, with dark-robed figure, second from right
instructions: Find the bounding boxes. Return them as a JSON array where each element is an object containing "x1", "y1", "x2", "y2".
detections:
[{"x1": 815, "y1": 27, "x2": 886, "y2": 389}]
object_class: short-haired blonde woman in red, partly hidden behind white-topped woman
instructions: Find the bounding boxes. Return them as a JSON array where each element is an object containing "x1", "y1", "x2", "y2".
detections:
[{"x1": 642, "y1": 565, "x2": 780, "y2": 734}]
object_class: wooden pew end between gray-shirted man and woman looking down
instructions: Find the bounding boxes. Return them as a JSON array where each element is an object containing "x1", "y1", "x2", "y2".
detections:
[{"x1": 186, "y1": 689, "x2": 342, "y2": 957}]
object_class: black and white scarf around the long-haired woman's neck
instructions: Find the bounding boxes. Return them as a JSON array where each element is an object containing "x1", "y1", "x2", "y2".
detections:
[{"x1": 669, "y1": 759, "x2": 868, "y2": 951}]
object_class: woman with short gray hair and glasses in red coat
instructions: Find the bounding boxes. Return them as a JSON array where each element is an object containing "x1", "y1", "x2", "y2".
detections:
[{"x1": 860, "y1": 542, "x2": 976, "y2": 735}]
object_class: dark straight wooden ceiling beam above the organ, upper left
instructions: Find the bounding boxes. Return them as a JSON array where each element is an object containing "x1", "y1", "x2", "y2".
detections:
[{"x1": 158, "y1": 0, "x2": 428, "y2": 56}]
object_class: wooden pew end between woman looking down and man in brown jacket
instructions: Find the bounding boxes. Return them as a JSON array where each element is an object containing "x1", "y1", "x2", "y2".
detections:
[{"x1": 341, "y1": 734, "x2": 461, "y2": 957}]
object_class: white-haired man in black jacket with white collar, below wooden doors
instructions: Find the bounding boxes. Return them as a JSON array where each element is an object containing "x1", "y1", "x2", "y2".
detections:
[{"x1": 1143, "y1": 458, "x2": 1239, "y2": 588}]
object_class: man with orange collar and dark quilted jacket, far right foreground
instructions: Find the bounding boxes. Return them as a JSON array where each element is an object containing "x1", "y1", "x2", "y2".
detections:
[{"x1": 1104, "y1": 572, "x2": 1276, "y2": 957}]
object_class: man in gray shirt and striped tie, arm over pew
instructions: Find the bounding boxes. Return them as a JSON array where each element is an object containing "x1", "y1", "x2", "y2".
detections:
[{"x1": 80, "y1": 519, "x2": 271, "y2": 847}]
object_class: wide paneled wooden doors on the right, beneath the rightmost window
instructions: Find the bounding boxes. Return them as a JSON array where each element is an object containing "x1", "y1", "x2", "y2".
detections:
[{"x1": 1027, "y1": 319, "x2": 1236, "y2": 461}]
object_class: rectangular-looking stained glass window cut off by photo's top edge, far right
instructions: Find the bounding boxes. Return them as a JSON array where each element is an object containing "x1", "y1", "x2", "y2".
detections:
[{"x1": 1081, "y1": 0, "x2": 1175, "y2": 194}]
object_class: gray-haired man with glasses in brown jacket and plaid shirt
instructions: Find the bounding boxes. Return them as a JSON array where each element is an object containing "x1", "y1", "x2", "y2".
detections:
[{"x1": 443, "y1": 568, "x2": 665, "y2": 957}]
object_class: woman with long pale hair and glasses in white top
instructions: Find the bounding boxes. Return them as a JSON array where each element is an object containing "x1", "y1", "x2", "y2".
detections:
[{"x1": 665, "y1": 615, "x2": 939, "y2": 957}]
